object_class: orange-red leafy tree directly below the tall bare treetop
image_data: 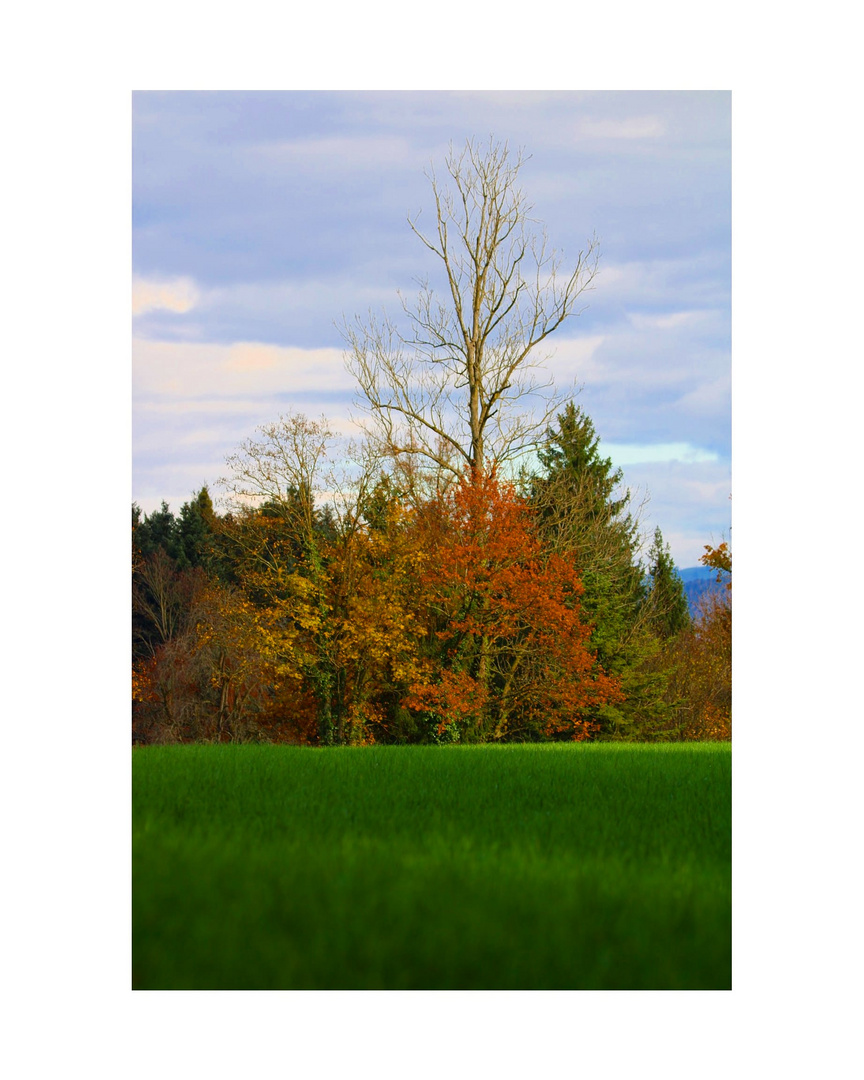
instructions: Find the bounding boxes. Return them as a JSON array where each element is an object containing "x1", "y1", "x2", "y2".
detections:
[{"x1": 405, "y1": 471, "x2": 621, "y2": 741}]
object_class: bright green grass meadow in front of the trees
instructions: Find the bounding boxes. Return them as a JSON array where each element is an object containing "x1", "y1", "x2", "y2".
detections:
[{"x1": 133, "y1": 743, "x2": 731, "y2": 989}]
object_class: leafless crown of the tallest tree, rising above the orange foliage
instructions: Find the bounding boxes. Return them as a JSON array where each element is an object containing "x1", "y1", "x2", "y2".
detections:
[{"x1": 342, "y1": 138, "x2": 598, "y2": 473}]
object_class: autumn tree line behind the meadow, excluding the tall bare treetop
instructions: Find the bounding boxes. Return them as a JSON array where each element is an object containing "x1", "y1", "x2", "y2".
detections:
[{"x1": 133, "y1": 404, "x2": 731, "y2": 745}]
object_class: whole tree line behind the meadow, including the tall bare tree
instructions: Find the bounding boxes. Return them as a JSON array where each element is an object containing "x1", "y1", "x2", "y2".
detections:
[{"x1": 133, "y1": 140, "x2": 731, "y2": 745}]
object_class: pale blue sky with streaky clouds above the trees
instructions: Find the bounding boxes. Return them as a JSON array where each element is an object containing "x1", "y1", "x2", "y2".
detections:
[{"x1": 132, "y1": 91, "x2": 731, "y2": 567}]
